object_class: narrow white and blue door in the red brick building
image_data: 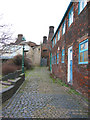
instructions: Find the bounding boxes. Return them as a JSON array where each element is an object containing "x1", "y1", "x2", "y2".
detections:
[{"x1": 68, "y1": 46, "x2": 73, "y2": 84}]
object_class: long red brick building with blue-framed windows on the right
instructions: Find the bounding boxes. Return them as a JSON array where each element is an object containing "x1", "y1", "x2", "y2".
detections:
[{"x1": 51, "y1": 0, "x2": 90, "y2": 95}]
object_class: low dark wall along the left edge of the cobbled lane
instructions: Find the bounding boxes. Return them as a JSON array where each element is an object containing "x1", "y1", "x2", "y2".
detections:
[{"x1": 0, "y1": 74, "x2": 25, "y2": 103}]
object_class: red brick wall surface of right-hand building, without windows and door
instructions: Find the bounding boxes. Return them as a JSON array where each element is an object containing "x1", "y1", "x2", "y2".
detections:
[{"x1": 52, "y1": 2, "x2": 88, "y2": 95}]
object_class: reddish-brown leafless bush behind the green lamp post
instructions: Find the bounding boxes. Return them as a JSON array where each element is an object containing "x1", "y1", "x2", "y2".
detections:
[{"x1": 2, "y1": 55, "x2": 32, "y2": 75}]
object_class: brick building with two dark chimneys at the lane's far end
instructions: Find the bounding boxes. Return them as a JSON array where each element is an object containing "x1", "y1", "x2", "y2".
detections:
[{"x1": 41, "y1": 26, "x2": 54, "y2": 66}]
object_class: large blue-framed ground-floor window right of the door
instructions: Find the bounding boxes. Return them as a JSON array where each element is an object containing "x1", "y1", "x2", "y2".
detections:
[{"x1": 79, "y1": 39, "x2": 88, "y2": 64}]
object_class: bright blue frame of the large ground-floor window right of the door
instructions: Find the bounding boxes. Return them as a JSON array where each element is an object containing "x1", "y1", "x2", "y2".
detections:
[{"x1": 79, "y1": 39, "x2": 88, "y2": 64}]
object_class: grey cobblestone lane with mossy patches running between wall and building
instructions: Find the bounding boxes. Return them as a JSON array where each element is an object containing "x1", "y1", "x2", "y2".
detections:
[{"x1": 2, "y1": 67, "x2": 88, "y2": 118}]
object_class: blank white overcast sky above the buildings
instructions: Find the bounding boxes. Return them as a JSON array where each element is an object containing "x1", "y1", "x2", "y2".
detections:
[{"x1": 0, "y1": 0, "x2": 71, "y2": 44}]
